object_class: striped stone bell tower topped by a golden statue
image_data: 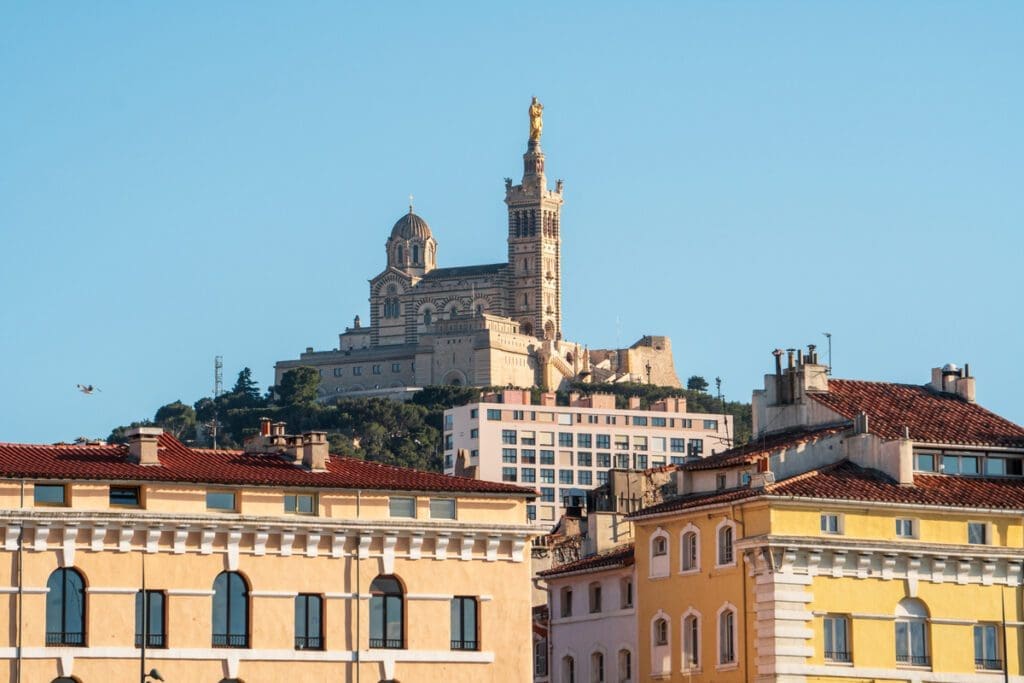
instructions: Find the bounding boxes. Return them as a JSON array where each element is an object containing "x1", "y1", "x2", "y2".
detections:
[{"x1": 505, "y1": 97, "x2": 562, "y2": 339}]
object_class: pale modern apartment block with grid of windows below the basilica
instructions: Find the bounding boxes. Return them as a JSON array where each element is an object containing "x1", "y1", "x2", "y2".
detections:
[{"x1": 444, "y1": 389, "x2": 733, "y2": 524}]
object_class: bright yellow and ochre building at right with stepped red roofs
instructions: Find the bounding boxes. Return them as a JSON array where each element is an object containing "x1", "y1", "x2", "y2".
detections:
[{"x1": 632, "y1": 349, "x2": 1024, "y2": 682}]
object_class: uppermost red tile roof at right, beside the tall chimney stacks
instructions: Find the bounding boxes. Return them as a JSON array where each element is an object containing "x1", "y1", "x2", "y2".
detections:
[{"x1": 807, "y1": 379, "x2": 1024, "y2": 446}]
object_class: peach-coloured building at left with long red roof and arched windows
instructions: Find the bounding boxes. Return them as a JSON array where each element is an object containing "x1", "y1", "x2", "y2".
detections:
[{"x1": 0, "y1": 422, "x2": 534, "y2": 683}]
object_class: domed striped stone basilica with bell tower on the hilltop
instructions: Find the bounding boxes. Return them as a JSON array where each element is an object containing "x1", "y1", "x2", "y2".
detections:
[{"x1": 274, "y1": 97, "x2": 679, "y2": 400}]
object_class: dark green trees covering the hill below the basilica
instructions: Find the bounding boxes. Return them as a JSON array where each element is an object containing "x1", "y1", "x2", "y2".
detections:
[{"x1": 106, "y1": 368, "x2": 751, "y2": 472}]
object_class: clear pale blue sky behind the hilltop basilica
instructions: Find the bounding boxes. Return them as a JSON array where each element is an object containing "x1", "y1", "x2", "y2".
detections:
[{"x1": 0, "y1": 0, "x2": 1024, "y2": 442}]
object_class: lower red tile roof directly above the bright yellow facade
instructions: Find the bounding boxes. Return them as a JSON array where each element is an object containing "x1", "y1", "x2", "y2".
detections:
[{"x1": 630, "y1": 460, "x2": 1024, "y2": 518}]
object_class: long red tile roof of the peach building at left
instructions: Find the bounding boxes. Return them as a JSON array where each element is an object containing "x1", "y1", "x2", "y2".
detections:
[{"x1": 0, "y1": 433, "x2": 536, "y2": 497}]
